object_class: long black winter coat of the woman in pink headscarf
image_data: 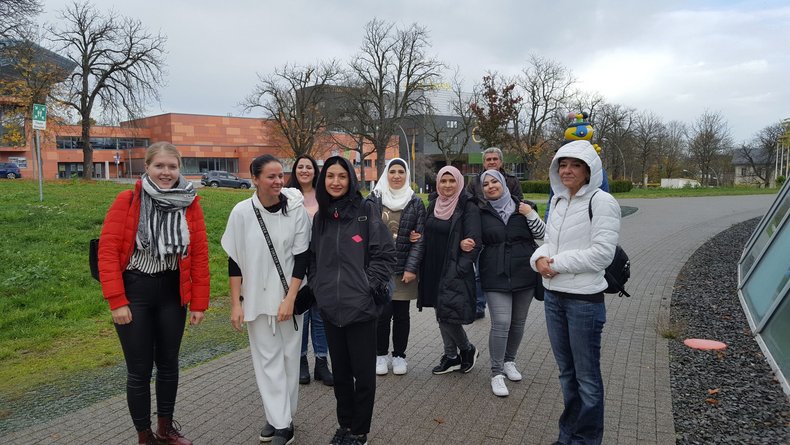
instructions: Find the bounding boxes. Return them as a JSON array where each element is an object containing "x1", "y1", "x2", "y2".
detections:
[{"x1": 417, "y1": 191, "x2": 481, "y2": 324}]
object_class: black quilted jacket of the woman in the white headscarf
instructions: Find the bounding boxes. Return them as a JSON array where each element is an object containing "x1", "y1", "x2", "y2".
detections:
[{"x1": 367, "y1": 193, "x2": 425, "y2": 275}]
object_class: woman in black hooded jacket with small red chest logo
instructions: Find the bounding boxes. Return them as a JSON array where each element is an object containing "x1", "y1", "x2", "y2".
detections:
[{"x1": 308, "y1": 156, "x2": 395, "y2": 445}]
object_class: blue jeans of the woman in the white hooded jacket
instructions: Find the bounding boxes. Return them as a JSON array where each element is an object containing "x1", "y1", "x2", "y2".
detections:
[{"x1": 543, "y1": 289, "x2": 606, "y2": 445}]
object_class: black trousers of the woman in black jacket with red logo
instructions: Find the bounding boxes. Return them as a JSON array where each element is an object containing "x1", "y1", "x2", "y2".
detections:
[{"x1": 324, "y1": 319, "x2": 376, "y2": 434}]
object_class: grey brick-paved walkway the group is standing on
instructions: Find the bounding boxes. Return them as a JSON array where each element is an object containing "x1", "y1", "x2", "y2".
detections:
[{"x1": 4, "y1": 195, "x2": 773, "y2": 444}]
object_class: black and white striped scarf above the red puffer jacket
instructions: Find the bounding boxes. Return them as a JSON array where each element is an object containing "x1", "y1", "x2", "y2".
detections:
[{"x1": 136, "y1": 174, "x2": 195, "y2": 261}]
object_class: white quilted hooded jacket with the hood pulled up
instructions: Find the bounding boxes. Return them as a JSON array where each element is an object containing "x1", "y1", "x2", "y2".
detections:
[{"x1": 530, "y1": 141, "x2": 620, "y2": 295}]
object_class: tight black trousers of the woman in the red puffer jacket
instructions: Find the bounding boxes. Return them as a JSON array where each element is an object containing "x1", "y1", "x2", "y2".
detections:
[{"x1": 115, "y1": 271, "x2": 186, "y2": 431}]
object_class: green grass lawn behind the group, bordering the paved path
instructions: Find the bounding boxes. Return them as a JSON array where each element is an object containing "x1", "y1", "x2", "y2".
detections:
[{"x1": 0, "y1": 180, "x2": 776, "y2": 398}]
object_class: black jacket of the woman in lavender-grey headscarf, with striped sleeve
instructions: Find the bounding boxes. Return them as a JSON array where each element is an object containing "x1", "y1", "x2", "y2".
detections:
[{"x1": 478, "y1": 199, "x2": 540, "y2": 293}]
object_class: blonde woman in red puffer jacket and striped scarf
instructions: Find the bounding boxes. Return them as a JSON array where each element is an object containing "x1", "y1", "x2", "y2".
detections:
[{"x1": 99, "y1": 142, "x2": 209, "y2": 445}]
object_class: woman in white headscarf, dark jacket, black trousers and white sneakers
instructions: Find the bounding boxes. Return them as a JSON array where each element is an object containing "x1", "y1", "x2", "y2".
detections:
[{"x1": 368, "y1": 158, "x2": 425, "y2": 375}]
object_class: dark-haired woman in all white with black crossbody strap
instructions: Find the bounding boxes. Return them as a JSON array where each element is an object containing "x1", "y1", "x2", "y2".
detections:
[{"x1": 222, "y1": 155, "x2": 310, "y2": 445}]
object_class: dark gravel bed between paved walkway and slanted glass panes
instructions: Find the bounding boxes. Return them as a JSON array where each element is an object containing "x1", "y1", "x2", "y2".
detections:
[{"x1": 669, "y1": 219, "x2": 790, "y2": 444}]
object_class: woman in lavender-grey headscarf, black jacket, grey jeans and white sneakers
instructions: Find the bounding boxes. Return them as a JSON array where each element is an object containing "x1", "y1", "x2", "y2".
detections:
[{"x1": 479, "y1": 170, "x2": 545, "y2": 397}]
